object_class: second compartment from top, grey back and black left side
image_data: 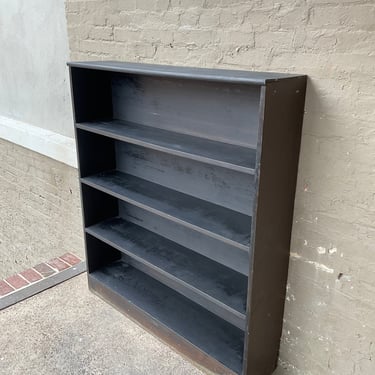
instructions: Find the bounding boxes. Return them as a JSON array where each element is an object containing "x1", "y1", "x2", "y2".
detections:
[{"x1": 77, "y1": 129, "x2": 255, "y2": 217}]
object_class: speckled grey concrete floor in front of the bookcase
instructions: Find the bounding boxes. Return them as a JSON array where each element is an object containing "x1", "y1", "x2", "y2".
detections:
[{"x1": 0, "y1": 274, "x2": 204, "y2": 375}]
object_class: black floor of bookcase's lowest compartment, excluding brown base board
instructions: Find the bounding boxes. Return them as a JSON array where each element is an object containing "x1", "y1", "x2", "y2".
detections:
[{"x1": 90, "y1": 261, "x2": 244, "y2": 373}]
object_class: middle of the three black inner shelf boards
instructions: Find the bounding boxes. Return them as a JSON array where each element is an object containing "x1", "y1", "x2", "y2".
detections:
[{"x1": 81, "y1": 170, "x2": 251, "y2": 252}]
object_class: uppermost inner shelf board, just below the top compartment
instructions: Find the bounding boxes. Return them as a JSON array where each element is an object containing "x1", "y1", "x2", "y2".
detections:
[{"x1": 76, "y1": 120, "x2": 256, "y2": 175}]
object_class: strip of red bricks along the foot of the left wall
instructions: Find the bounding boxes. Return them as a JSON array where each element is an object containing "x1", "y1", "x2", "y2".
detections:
[{"x1": 0, "y1": 253, "x2": 82, "y2": 299}]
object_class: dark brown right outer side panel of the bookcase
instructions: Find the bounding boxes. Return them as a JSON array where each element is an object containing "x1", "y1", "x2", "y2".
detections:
[{"x1": 243, "y1": 76, "x2": 306, "y2": 375}]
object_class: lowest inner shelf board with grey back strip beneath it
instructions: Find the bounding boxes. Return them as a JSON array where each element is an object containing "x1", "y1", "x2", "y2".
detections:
[{"x1": 86, "y1": 218, "x2": 247, "y2": 329}]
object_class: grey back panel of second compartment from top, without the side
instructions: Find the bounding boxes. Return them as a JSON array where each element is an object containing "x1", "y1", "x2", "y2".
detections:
[{"x1": 116, "y1": 142, "x2": 254, "y2": 215}]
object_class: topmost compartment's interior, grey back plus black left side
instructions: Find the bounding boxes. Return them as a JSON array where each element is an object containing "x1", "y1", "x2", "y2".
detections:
[{"x1": 72, "y1": 69, "x2": 260, "y2": 145}]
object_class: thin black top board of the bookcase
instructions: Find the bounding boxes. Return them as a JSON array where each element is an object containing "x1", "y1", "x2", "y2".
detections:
[{"x1": 68, "y1": 61, "x2": 305, "y2": 85}]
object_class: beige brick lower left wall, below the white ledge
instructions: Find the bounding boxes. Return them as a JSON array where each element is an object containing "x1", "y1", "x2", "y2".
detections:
[{"x1": 0, "y1": 140, "x2": 84, "y2": 279}]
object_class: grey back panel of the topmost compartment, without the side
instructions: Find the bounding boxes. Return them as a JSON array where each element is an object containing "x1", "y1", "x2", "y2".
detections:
[{"x1": 112, "y1": 75, "x2": 260, "y2": 147}]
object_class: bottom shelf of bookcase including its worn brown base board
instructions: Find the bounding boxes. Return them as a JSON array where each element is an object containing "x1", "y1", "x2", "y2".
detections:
[{"x1": 89, "y1": 261, "x2": 244, "y2": 374}]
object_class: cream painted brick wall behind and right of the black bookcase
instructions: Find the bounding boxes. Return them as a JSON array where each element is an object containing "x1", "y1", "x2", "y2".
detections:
[{"x1": 66, "y1": 0, "x2": 375, "y2": 375}]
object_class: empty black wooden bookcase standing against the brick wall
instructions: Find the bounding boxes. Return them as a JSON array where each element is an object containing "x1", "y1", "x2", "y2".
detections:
[{"x1": 68, "y1": 62, "x2": 306, "y2": 375}]
